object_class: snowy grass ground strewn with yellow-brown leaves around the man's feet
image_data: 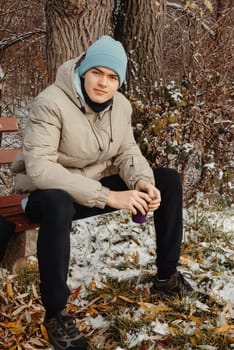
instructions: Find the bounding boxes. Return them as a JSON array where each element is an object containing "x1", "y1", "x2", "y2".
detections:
[{"x1": 0, "y1": 205, "x2": 234, "y2": 350}]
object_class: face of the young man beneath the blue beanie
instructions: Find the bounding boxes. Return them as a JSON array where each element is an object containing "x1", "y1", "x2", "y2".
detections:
[{"x1": 83, "y1": 67, "x2": 119, "y2": 103}]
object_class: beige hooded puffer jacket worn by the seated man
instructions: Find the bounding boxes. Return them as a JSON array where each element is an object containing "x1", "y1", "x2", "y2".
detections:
[{"x1": 13, "y1": 59, "x2": 154, "y2": 208}]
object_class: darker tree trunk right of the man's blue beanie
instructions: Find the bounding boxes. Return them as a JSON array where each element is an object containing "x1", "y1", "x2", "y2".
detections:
[{"x1": 115, "y1": 0, "x2": 165, "y2": 98}]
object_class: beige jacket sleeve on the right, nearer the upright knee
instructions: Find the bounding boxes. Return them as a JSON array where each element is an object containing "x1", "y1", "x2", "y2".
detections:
[{"x1": 114, "y1": 103, "x2": 154, "y2": 189}]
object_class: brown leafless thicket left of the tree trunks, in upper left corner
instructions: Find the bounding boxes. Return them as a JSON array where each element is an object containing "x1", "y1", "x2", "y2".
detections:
[{"x1": 0, "y1": 0, "x2": 47, "y2": 106}]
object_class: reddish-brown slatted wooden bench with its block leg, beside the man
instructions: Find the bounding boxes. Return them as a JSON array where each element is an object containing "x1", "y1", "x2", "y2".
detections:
[{"x1": 0, "y1": 117, "x2": 37, "y2": 265}]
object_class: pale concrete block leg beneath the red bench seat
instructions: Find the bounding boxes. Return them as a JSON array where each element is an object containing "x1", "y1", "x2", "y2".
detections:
[{"x1": 3, "y1": 229, "x2": 38, "y2": 270}]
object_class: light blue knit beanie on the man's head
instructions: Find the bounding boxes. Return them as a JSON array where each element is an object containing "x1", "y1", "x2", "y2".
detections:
[{"x1": 79, "y1": 35, "x2": 127, "y2": 86}]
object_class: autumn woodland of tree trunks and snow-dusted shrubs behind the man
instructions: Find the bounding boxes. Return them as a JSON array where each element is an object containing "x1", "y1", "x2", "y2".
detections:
[{"x1": 0, "y1": 0, "x2": 234, "y2": 204}]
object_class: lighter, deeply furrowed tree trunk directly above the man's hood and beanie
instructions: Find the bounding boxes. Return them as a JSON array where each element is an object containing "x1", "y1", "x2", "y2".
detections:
[{"x1": 46, "y1": 0, "x2": 114, "y2": 82}]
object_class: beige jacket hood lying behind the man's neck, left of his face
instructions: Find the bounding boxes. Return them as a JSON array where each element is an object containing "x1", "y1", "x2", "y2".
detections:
[{"x1": 54, "y1": 53, "x2": 84, "y2": 107}]
